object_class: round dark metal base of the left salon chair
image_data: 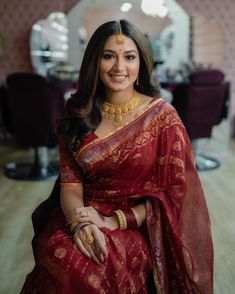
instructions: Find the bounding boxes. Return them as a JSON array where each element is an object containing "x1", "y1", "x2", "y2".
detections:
[{"x1": 4, "y1": 162, "x2": 59, "y2": 181}]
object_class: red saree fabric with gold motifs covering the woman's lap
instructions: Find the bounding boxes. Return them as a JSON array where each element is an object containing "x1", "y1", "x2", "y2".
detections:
[{"x1": 31, "y1": 210, "x2": 151, "y2": 293}]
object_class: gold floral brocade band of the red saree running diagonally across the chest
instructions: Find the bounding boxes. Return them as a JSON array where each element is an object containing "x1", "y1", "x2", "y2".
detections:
[{"x1": 76, "y1": 101, "x2": 173, "y2": 171}]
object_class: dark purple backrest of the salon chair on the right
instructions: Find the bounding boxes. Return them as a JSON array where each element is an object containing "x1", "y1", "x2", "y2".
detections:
[{"x1": 172, "y1": 70, "x2": 227, "y2": 139}]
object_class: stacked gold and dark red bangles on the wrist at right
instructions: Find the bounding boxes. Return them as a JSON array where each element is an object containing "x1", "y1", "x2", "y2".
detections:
[{"x1": 113, "y1": 208, "x2": 142, "y2": 230}]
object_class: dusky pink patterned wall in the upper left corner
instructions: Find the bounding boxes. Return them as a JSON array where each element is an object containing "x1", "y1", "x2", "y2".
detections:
[{"x1": 0, "y1": 0, "x2": 80, "y2": 84}]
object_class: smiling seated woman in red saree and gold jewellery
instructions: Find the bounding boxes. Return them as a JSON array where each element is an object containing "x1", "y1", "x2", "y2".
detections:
[{"x1": 22, "y1": 20, "x2": 213, "y2": 294}]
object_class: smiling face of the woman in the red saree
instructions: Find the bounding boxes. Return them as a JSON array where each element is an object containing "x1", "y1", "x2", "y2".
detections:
[{"x1": 99, "y1": 35, "x2": 140, "y2": 91}]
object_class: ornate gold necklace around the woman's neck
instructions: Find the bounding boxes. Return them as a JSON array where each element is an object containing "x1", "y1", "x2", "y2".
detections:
[{"x1": 102, "y1": 92, "x2": 140, "y2": 126}]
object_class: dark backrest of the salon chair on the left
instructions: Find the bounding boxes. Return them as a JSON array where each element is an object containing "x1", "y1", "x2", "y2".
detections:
[{"x1": 6, "y1": 73, "x2": 64, "y2": 147}]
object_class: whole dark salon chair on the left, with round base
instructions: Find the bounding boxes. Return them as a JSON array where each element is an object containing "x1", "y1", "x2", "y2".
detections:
[{"x1": 4, "y1": 73, "x2": 64, "y2": 180}]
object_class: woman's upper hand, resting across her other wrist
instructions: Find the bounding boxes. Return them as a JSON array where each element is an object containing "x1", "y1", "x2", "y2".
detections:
[{"x1": 68, "y1": 206, "x2": 118, "y2": 230}]
